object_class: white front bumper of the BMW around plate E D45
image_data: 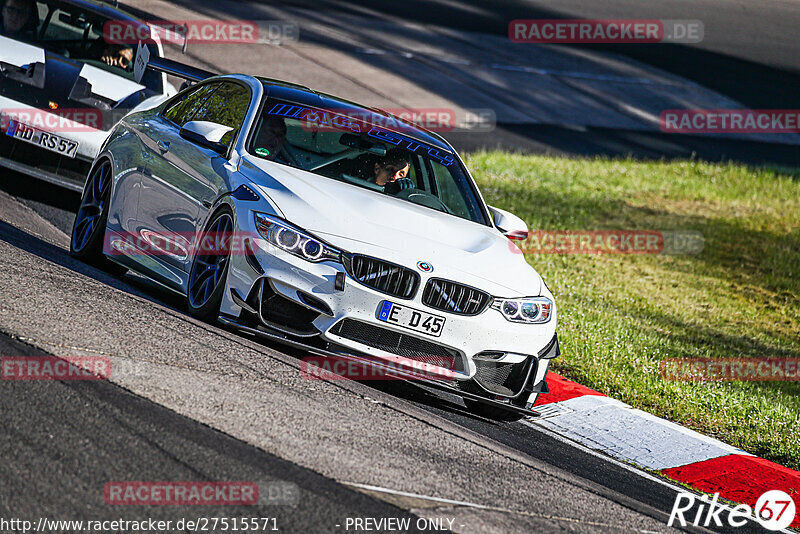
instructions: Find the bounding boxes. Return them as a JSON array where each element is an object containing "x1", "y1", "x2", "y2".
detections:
[{"x1": 220, "y1": 210, "x2": 558, "y2": 400}]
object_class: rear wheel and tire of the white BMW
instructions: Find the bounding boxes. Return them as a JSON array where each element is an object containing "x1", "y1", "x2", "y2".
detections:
[{"x1": 69, "y1": 159, "x2": 128, "y2": 276}]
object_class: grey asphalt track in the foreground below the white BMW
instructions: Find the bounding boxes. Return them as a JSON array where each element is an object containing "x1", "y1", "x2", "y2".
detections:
[{"x1": 0, "y1": 175, "x2": 776, "y2": 532}]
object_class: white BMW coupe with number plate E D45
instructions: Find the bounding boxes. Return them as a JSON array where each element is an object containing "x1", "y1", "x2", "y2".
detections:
[{"x1": 71, "y1": 62, "x2": 559, "y2": 419}]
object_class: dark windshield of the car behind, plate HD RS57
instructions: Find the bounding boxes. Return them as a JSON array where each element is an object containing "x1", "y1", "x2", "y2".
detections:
[{"x1": 0, "y1": 0, "x2": 164, "y2": 93}]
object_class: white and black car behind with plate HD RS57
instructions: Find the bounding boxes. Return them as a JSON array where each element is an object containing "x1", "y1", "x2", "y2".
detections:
[{"x1": 0, "y1": 0, "x2": 177, "y2": 191}]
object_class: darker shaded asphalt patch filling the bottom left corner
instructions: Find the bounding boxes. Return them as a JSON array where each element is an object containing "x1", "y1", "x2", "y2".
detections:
[{"x1": 0, "y1": 333, "x2": 428, "y2": 532}]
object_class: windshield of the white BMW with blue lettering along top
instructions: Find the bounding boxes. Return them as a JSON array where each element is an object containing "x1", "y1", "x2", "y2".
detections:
[{"x1": 248, "y1": 99, "x2": 488, "y2": 224}]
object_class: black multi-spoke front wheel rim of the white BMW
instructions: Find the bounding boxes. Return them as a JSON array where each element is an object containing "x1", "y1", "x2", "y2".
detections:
[{"x1": 189, "y1": 213, "x2": 233, "y2": 308}]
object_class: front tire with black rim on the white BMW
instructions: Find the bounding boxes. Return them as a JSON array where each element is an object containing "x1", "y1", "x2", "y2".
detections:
[{"x1": 186, "y1": 206, "x2": 233, "y2": 322}]
